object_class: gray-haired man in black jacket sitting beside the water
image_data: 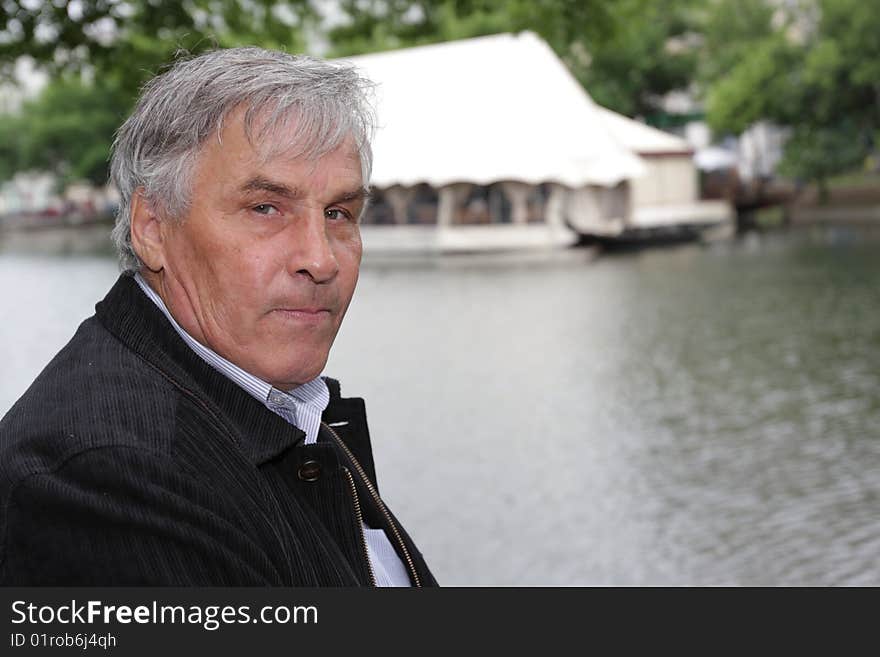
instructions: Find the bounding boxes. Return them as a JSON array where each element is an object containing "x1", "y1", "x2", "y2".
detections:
[{"x1": 0, "y1": 48, "x2": 436, "y2": 586}]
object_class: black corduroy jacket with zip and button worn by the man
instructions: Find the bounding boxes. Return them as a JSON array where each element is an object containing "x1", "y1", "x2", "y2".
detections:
[{"x1": 0, "y1": 275, "x2": 436, "y2": 586}]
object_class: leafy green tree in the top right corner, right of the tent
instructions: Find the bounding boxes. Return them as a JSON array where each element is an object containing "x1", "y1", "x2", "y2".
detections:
[{"x1": 705, "y1": 0, "x2": 880, "y2": 198}]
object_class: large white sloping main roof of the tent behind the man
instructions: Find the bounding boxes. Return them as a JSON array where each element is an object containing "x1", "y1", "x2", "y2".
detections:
[{"x1": 346, "y1": 32, "x2": 644, "y2": 187}]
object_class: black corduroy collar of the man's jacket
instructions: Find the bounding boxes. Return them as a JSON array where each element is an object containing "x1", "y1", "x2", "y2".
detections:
[{"x1": 95, "y1": 274, "x2": 332, "y2": 465}]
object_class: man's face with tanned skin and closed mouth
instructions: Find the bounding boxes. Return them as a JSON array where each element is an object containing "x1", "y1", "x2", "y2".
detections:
[{"x1": 149, "y1": 113, "x2": 365, "y2": 389}]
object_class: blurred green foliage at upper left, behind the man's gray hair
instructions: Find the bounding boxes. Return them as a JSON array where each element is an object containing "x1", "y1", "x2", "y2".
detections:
[{"x1": 0, "y1": 0, "x2": 317, "y2": 184}]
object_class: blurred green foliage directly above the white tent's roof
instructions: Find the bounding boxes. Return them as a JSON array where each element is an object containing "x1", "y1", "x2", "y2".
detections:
[{"x1": 328, "y1": 0, "x2": 696, "y2": 116}]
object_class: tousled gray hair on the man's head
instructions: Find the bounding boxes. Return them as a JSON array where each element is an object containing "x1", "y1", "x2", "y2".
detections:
[{"x1": 110, "y1": 47, "x2": 375, "y2": 271}]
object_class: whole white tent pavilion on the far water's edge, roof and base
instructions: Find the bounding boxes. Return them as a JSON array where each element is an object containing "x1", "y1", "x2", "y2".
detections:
[{"x1": 336, "y1": 32, "x2": 727, "y2": 251}]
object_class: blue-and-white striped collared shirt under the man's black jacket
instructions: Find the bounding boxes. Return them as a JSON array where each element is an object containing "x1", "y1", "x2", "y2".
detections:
[{"x1": 134, "y1": 274, "x2": 410, "y2": 586}]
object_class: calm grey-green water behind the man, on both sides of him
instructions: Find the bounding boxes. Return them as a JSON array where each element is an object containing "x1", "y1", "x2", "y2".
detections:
[{"x1": 0, "y1": 228, "x2": 880, "y2": 585}]
